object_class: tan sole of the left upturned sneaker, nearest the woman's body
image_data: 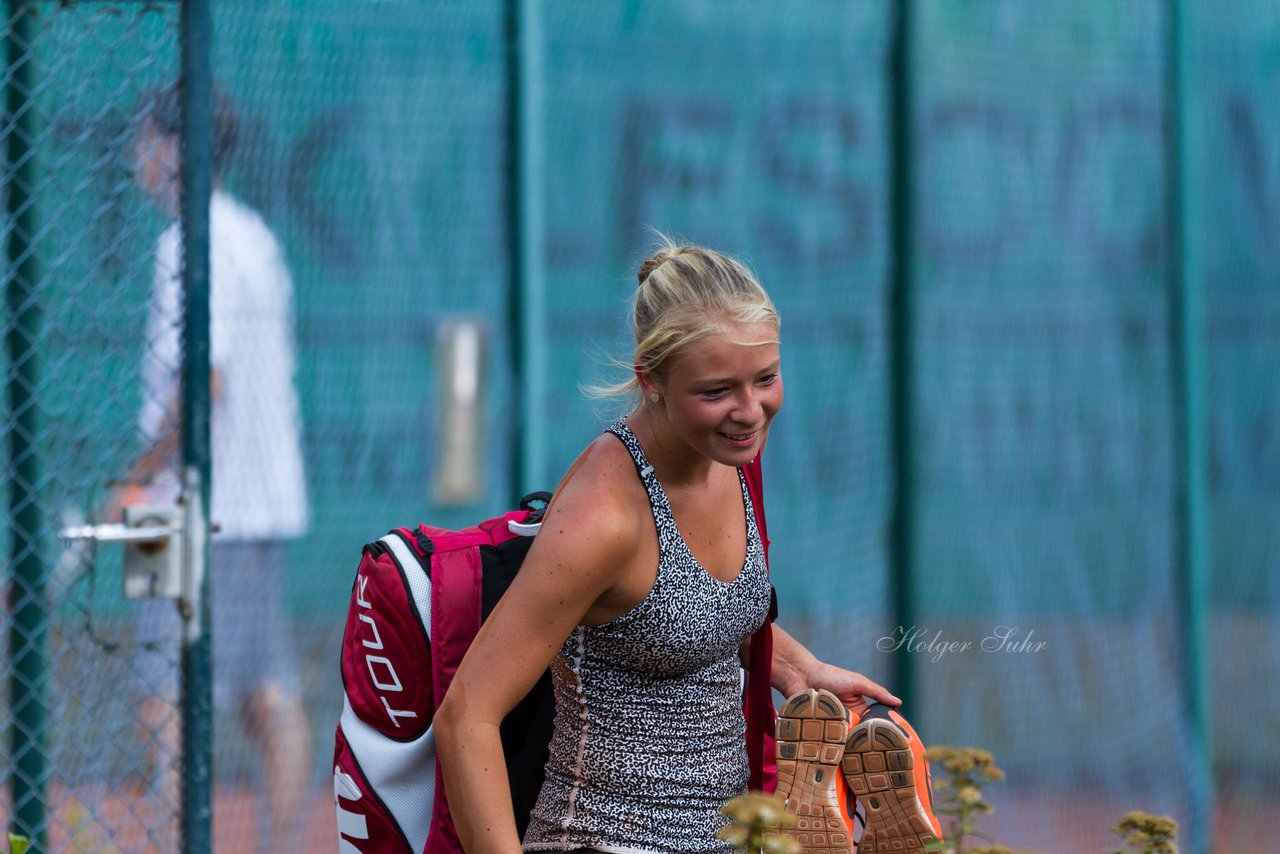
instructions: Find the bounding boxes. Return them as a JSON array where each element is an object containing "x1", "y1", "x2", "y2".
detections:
[{"x1": 777, "y1": 689, "x2": 852, "y2": 854}]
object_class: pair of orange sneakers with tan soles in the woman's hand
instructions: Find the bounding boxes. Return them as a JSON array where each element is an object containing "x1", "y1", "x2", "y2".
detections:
[{"x1": 777, "y1": 689, "x2": 942, "y2": 854}]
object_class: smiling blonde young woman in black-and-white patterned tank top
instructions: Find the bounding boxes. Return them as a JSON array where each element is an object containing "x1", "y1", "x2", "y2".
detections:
[{"x1": 435, "y1": 243, "x2": 899, "y2": 854}]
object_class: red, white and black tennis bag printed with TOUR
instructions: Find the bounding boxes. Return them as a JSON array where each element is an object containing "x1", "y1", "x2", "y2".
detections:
[{"x1": 333, "y1": 493, "x2": 554, "y2": 854}]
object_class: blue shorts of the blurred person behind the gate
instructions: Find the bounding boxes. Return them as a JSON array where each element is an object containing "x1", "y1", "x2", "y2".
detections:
[{"x1": 133, "y1": 539, "x2": 298, "y2": 709}]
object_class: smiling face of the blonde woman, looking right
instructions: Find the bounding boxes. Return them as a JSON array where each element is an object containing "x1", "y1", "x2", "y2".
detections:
[{"x1": 653, "y1": 324, "x2": 782, "y2": 466}]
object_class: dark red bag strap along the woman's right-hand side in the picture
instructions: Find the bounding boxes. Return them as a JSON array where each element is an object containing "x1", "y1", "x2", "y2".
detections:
[{"x1": 742, "y1": 452, "x2": 777, "y2": 793}]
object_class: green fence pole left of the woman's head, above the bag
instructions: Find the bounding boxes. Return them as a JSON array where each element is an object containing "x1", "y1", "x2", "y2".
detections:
[{"x1": 507, "y1": 0, "x2": 549, "y2": 499}]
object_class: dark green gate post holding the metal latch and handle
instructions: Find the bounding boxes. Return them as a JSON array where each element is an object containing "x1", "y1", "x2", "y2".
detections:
[{"x1": 182, "y1": 0, "x2": 214, "y2": 854}]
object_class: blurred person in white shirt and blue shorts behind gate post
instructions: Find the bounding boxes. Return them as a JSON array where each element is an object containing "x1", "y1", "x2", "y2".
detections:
[{"x1": 113, "y1": 86, "x2": 312, "y2": 851}]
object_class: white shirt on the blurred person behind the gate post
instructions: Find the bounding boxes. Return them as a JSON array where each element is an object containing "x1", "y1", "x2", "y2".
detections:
[{"x1": 140, "y1": 191, "x2": 307, "y2": 540}]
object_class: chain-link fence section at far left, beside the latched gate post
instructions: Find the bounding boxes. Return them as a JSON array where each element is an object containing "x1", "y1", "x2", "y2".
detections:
[{"x1": 0, "y1": 3, "x2": 188, "y2": 851}]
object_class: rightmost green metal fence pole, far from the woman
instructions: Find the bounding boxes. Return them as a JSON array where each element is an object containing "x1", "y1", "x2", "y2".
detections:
[{"x1": 1165, "y1": 0, "x2": 1215, "y2": 853}]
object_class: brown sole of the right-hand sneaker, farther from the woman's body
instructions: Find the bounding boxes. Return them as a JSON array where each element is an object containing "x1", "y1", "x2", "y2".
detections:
[{"x1": 844, "y1": 718, "x2": 938, "y2": 854}]
